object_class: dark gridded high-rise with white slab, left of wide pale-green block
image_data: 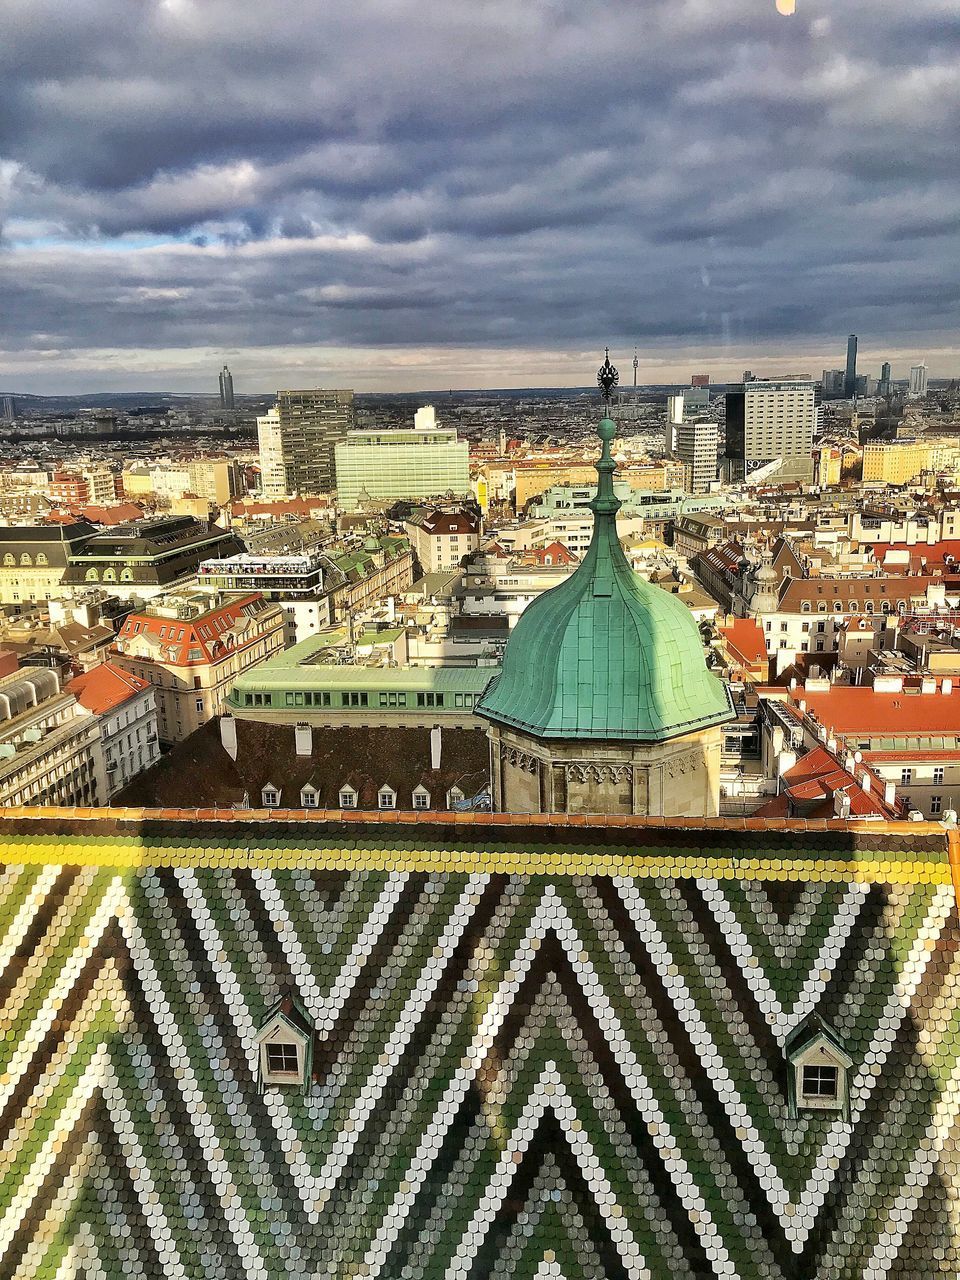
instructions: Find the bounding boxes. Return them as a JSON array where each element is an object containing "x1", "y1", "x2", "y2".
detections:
[{"x1": 257, "y1": 390, "x2": 355, "y2": 498}]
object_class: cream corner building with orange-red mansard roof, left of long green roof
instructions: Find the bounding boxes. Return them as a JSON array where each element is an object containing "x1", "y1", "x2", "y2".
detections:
[{"x1": 111, "y1": 591, "x2": 284, "y2": 742}]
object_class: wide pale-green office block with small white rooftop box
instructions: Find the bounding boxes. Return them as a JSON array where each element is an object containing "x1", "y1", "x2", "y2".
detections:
[{"x1": 335, "y1": 406, "x2": 471, "y2": 511}]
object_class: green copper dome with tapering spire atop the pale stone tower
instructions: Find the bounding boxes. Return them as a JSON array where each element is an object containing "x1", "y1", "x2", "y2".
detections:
[{"x1": 477, "y1": 417, "x2": 733, "y2": 742}]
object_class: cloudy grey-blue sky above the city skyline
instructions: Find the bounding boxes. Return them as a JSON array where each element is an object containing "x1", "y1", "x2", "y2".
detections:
[{"x1": 0, "y1": 0, "x2": 960, "y2": 394}]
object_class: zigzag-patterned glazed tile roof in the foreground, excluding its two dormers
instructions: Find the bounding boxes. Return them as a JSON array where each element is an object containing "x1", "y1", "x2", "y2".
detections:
[{"x1": 0, "y1": 810, "x2": 960, "y2": 1280}]
